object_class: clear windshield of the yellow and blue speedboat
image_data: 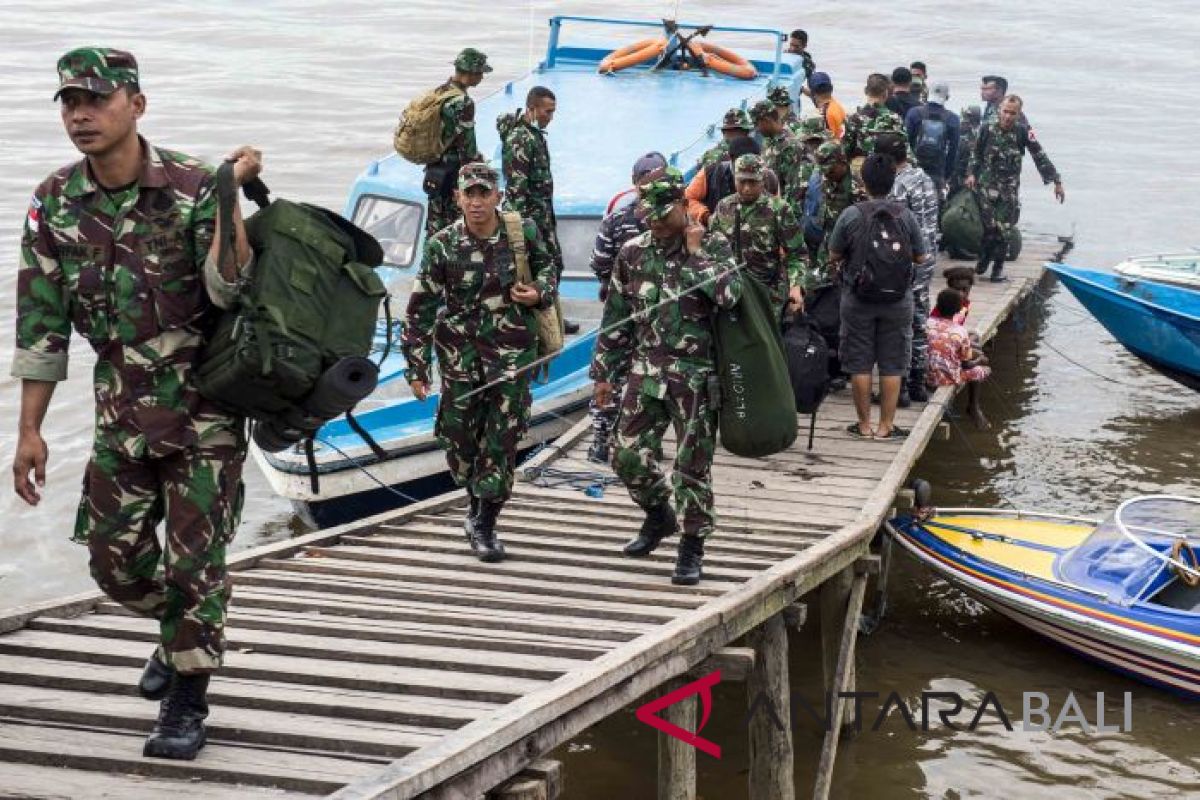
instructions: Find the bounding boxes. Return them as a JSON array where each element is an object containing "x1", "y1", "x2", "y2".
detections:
[{"x1": 1060, "y1": 495, "x2": 1200, "y2": 604}]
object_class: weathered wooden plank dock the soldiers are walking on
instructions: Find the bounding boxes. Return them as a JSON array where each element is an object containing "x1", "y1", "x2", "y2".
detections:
[{"x1": 0, "y1": 237, "x2": 1060, "y2": 800}]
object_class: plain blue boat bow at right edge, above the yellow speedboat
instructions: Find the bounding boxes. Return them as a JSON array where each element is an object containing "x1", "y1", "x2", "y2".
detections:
[{"x1": 1049, "y1": 264, "x2": 1200, "y2": 391}]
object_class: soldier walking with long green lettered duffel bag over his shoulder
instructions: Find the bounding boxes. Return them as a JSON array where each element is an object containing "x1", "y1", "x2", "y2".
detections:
[{"x1": 590, "y1": 168, "x2": 742, "y2": 585}]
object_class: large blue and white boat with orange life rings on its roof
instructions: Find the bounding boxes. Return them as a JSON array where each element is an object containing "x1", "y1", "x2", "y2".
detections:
[{"x1": 253, "y1": 17, "x2": 805, "y2": 524}]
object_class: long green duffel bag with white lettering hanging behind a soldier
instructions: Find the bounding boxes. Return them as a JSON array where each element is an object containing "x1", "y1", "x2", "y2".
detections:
[{"x1": 715, "y1": 272, "x2": 797, "y2": 458}]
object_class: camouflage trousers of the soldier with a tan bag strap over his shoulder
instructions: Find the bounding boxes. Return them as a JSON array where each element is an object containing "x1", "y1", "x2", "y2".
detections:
[{"x1": 434, "y1": 373, "x2": 532, "y2": 503}]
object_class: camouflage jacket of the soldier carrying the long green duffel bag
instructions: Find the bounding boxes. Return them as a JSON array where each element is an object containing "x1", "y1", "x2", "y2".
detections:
[{"x1": 589, "y1": 231, "x2": 742, "y2": 398}]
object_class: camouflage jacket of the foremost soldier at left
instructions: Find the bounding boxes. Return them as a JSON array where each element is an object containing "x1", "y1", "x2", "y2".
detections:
[{"x1": 12, "y1": 139, "x2": 236, "y2": 458}]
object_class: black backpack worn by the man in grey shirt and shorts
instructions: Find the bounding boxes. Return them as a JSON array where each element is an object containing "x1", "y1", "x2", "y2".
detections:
[{"x1": 845, "y1": 200, "x2": 912, "y2": 302}]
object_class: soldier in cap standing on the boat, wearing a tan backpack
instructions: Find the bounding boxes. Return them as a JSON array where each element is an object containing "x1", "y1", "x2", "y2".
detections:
[{"x1": 425, "y1": 47, "x2": 492, "y2": 236}]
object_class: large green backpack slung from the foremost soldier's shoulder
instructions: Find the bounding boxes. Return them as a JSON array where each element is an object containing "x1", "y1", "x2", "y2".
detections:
[{"x1": 194, "y1": 164, "x2": 388, "y2": 451}]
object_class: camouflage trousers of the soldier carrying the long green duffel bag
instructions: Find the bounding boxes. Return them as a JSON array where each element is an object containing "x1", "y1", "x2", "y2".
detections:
[{"x1": 612, "y1": 374, "x2": 716, "y2": 537}]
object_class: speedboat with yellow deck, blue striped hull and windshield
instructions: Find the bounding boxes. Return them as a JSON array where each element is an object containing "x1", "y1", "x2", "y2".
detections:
[{"x1": 888, "y1": 495, "x2": 1200, "y2": 699}]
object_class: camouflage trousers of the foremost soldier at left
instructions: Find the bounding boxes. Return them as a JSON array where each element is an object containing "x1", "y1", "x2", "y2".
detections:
[{"x1": 73, "y1": 428, "x2": 246, "y2": 674}]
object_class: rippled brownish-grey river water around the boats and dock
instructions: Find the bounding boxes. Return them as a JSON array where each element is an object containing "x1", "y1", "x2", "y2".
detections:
[{"x1": 0, "y1": 0, "x2": 1200, "y2": 800}]
